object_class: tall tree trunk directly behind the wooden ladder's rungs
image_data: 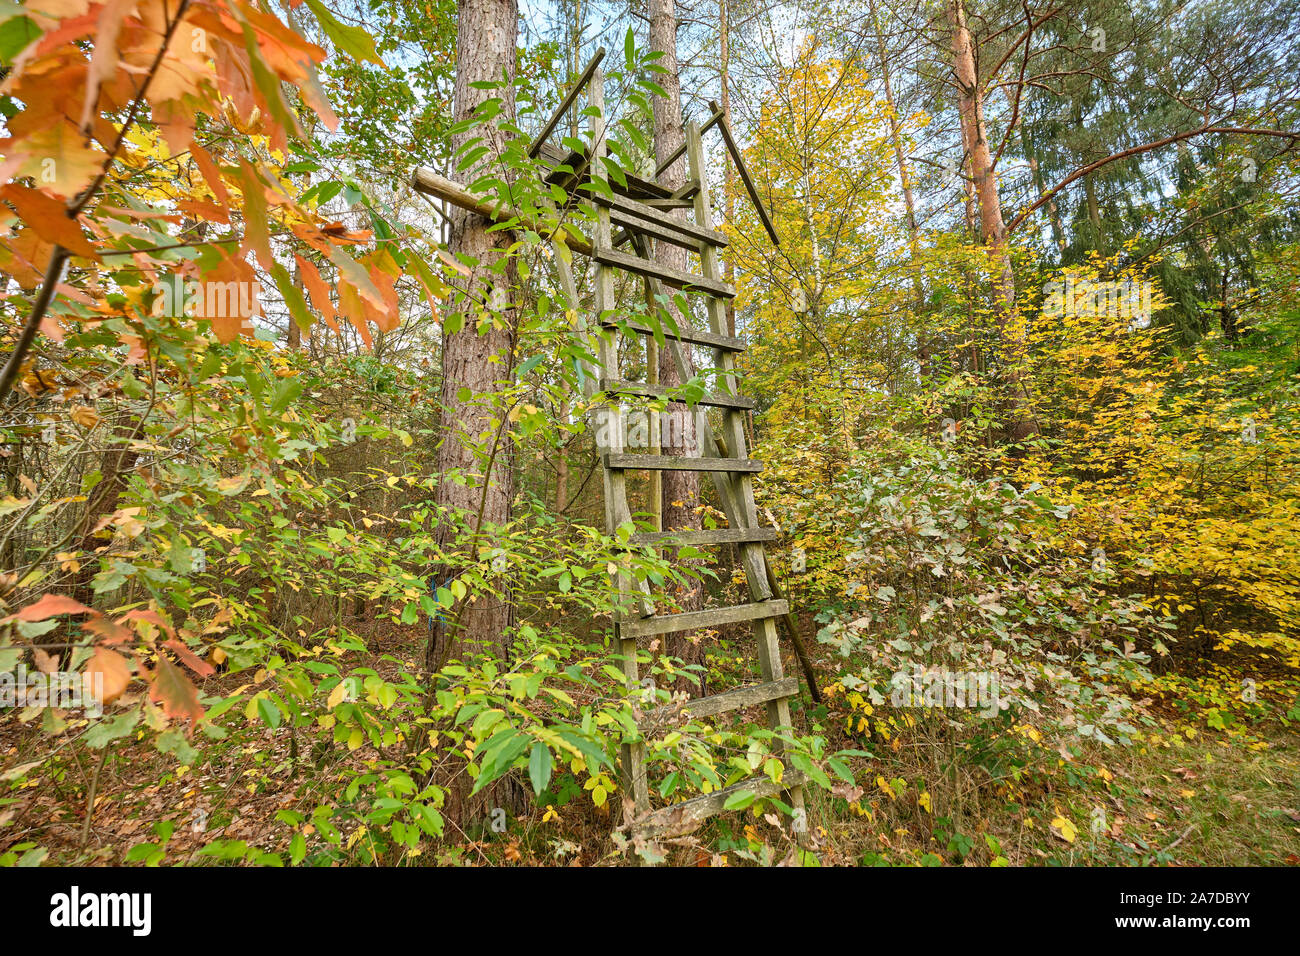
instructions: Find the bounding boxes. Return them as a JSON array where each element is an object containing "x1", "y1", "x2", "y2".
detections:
[{"x1": 650, "y1": 0, "x2": 703, "y2": 689}]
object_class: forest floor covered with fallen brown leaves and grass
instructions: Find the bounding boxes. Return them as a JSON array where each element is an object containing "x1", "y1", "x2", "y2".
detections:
[{"x1": 0, "y1": 616, "x2": 1300, "y2": 866}]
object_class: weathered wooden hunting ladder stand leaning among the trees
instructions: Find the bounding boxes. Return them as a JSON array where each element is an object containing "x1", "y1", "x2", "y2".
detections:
[{"x1": 412, "y1": 49, "x2": 818, "y2": 838}]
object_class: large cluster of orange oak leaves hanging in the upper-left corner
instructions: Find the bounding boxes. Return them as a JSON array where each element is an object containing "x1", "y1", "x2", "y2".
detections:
[{"x1": 0, "y1": 0, "x2": 399, "y2": 359}]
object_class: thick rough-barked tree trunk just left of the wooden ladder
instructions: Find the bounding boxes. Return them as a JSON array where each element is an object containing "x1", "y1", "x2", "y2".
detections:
[{"x1": 426, "y1": 0, "x2": 519, "y2": 669}]
